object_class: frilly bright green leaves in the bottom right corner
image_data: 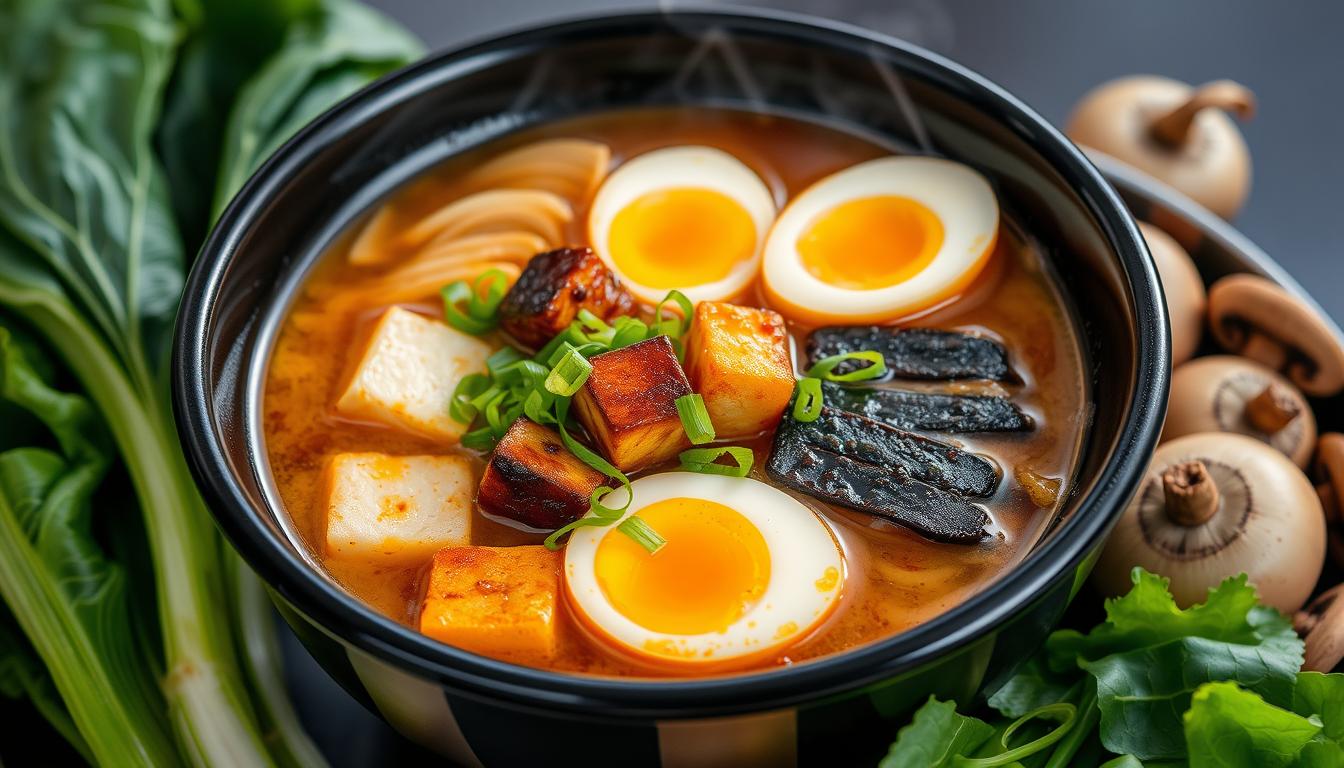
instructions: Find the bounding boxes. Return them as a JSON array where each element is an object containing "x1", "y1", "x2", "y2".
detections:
[{"x1": 884, "y1": 569, "x2": 1344, "y2": 768}]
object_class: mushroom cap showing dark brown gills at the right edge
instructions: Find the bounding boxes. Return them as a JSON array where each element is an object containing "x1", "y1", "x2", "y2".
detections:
[{"x1": 1208, "y1": 273, "x2": 1344, "y2": 397}]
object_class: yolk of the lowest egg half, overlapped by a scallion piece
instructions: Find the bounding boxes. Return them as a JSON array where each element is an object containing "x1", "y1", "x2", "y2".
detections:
[{"x1": 593, "y1": 498, "x2": 770, "y2": 635}]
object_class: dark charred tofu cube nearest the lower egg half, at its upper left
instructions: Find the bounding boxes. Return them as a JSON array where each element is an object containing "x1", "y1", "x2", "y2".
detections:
[{"x1": 476, "y1": 417, "x2": 606, "y2": 530}]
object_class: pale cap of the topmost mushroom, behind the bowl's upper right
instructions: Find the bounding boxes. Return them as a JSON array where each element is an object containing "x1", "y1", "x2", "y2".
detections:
[{"x1": 1064, "y1": 75, "x2": 1251, "y2": 218}]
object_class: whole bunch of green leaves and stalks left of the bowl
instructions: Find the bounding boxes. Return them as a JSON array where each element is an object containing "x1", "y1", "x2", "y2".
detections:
[{"x1": 0, "y1": 0, "x2": 418, "y2": 765}]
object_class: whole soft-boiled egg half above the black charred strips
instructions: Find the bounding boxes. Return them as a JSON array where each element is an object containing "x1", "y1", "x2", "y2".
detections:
[{"x1": 762, "y1": 157, "x2": 999, "y2": 324}]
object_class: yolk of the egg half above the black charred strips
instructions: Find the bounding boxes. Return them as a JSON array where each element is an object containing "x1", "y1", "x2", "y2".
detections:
[{"x1": 797, "y1": 195, "x2": 942, "y2": 291}]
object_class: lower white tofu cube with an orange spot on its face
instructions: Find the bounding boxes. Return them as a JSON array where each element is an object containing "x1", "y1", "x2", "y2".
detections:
[{"x1": 327, "y1": 453, "x2": 474, "y2": 564}]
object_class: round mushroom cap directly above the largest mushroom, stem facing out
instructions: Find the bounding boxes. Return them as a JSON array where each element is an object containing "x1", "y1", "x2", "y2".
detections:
[{"x1": 1161, "y1": 355, "x2": 1311, "y2": 468}]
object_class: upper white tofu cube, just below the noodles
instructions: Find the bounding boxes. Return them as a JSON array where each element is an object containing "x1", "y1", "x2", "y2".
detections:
[{"x1": 336, "y1": 307, "x2": 491, "y2": 443}]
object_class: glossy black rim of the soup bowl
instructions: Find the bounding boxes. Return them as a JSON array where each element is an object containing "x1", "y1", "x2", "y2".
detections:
[{"x1": 172, "y1": 8, "x2": 1171, "y2": 720}]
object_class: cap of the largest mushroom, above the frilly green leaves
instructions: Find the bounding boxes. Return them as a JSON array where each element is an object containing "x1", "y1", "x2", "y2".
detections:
[{"x1": 1093, "y1": 432, "x2": 1325, "y2": 613}]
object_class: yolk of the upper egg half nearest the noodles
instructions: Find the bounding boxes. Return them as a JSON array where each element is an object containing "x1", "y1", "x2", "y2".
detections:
[{"x1": 607, "y1": 187, "x2": 757, "y2": 288}]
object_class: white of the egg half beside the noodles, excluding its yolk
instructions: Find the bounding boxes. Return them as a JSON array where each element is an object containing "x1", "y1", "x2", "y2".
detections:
[{"x1": 589, "y1": 145, "x2": 775, "y2": 304}]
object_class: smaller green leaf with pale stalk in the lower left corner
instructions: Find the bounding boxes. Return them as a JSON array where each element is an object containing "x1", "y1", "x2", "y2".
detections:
[{"x1": 0, "y1": 327, "x2": 176, "y2": 764}]
